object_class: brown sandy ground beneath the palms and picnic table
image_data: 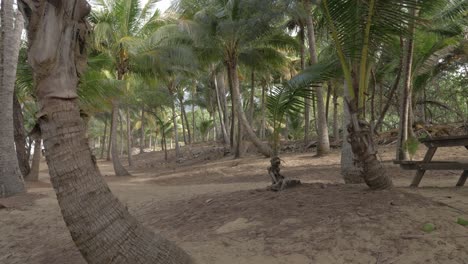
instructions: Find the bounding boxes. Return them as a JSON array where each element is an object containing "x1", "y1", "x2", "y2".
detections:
[{"x1": 0, "y1": 145, "x2": 468, "y2": 264}]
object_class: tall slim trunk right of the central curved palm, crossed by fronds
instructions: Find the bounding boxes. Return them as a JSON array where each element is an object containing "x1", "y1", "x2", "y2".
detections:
[{"x1": 303, "y1": 1, "x2": 330, "y2": 156}]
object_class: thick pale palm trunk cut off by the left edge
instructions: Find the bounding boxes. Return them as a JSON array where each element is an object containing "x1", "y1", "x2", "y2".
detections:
[{"x1": 0, "y1": 0, "x2": 24, "y2": 197}]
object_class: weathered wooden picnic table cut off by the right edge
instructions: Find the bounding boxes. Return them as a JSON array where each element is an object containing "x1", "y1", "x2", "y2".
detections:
[{"x1": 394, "y1": 135, "x2": 468, "y2": 187}]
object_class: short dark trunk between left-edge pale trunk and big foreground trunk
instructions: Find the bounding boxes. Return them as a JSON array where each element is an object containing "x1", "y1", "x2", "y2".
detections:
[{"x1": 13, "y1": 93, "x2": 31, "y2": 177}]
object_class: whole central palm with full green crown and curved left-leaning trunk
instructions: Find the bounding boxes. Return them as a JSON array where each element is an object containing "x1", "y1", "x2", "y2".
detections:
[{"x1": 179, "y1": 0, "x2": 298, "y2": 157}]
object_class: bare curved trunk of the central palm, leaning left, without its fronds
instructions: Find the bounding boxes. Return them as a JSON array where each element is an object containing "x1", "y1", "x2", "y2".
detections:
[{"x1": 228, "y1": 60, "x2": 273, "y2": 157}]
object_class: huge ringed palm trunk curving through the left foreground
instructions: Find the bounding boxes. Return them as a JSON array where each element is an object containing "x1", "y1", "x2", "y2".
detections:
[{"x1": 21, "y1": 0, "x2": 192, "y2": 264}]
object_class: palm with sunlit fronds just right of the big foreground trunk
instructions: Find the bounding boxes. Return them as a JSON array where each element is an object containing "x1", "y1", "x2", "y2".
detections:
[{"x1": 92, "y1": 0, "x2": 165, "y2": 176}]
